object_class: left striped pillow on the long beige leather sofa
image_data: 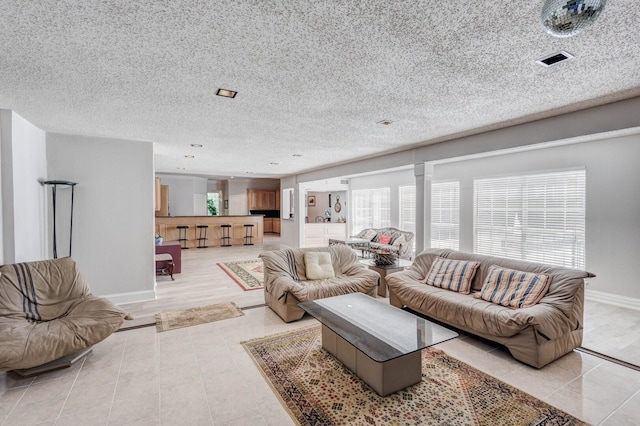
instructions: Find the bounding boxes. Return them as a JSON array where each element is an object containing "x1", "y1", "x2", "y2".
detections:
[{"x1": 425, "y1": 257, "x2": 480, "y2": 294}]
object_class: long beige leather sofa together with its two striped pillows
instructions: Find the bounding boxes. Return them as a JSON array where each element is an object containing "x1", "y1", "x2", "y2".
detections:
[{"x1": 386, "y1": 249, "x2": 594, "y2": 368}]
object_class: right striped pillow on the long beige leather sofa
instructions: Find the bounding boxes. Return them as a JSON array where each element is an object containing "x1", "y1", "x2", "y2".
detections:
[{"x1": 475, "y1": 265, "x2": 551, "y2": 308}]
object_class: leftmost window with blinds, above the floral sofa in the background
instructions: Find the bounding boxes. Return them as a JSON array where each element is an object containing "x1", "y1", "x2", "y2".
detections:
[{"x1": 351, "y1": 188, "x2": 391, "y2": 234}]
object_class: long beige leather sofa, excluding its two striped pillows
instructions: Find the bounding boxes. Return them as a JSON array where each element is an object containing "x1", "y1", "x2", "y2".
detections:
[{"x1": 386, "y1": 249, "x2": 594, "y2": 368}]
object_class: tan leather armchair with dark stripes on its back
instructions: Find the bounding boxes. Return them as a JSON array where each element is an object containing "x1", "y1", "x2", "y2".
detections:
[{"x1": 0, "y1": 257, "x2": 127, "y2": 371}]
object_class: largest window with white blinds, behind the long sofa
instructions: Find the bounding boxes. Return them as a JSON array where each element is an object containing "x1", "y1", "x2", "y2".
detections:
[{"x1": 474, "y1": 170, "x2": 586, "y2": 269}]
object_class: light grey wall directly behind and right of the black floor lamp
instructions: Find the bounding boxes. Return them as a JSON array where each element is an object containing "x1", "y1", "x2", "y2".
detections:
[{"x1": 47, "y1": 133, "x2": 155, "y2": 303}]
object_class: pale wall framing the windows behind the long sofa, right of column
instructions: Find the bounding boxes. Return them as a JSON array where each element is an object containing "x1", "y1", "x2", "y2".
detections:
[{"x1": 433, "y1": 135, "x2": 640, "y2": 299}]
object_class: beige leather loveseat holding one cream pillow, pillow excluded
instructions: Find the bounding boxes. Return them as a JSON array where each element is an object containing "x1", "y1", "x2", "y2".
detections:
[{"x1": 260, "y1": 244, "x2": 380, "y2": 322}]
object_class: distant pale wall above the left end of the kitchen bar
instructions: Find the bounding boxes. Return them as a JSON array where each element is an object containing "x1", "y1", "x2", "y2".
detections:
[{"x1": 156, "y1": 174, "x2": 207, "y2": 216}]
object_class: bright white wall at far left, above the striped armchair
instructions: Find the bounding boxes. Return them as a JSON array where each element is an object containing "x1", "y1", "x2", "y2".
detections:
[{"x1": 0, "y1": 110, "x2": 47, "y2": 263}]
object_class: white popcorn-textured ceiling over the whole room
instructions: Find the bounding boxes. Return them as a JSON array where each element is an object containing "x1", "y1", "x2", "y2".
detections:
[{"x1": 0, "y1": 0, "x2": 640, "y2": 177}]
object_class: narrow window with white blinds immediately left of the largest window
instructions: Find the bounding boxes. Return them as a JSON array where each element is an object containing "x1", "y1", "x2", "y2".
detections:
[{"x1": 431, "y1": 181, "x2": 460, "y2": 250}]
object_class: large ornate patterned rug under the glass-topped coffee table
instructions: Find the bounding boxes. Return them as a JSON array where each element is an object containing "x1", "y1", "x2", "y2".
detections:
[{"x1": 243, "y1": 326, "x2": 585, "y2": 426}]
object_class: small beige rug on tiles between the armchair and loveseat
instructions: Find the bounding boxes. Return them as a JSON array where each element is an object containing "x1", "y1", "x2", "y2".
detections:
[{"x1": 156, "y1": 302, "x2": 244, "y2": 333}]
